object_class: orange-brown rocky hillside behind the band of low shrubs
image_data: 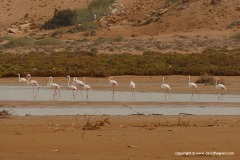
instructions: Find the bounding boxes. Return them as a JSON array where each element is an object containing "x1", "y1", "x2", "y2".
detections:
[{"x1": 0, "y1": 0, "x2": 240, "y2": 54}]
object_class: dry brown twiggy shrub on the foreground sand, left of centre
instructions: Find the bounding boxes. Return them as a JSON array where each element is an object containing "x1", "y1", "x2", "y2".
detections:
[{"x1": 82, "y1": 117, "x2": 111, "y2": 130}]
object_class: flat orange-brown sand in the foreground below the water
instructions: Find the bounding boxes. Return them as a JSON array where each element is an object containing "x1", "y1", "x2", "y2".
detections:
[{"x1": 0, "y1": 116, "x2": 240, "y2": 160}]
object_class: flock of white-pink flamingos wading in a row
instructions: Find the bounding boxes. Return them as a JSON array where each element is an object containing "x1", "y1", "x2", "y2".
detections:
[{"x1": 15, "y1": 74, "x2": 227, "y2": 101}]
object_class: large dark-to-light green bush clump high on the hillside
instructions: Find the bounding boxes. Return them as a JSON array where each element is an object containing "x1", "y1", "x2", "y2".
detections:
[{"x1": 42, "y1": 0, "x2": 115, "y2": 29}]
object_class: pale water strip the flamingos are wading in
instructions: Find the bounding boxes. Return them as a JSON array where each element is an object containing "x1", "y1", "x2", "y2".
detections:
[{"x1": 0, "y1": 86, "x2": 240, "y2": 102}]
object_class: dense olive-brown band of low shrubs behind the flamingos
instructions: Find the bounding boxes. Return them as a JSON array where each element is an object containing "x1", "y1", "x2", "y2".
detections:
[{"x1": 0, "y1": 50, "x2": 240, "y2": 77}]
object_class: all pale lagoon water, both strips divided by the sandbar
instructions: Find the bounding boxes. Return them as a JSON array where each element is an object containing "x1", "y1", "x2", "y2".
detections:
[{"x1": 0, "y1": 86, "x2": 240, "y2": 116}]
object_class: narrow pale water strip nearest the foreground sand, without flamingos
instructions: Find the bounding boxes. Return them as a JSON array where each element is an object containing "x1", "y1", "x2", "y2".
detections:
[{"x1": 0, "y1": 106, "x2": 240, "y2": 116}]
